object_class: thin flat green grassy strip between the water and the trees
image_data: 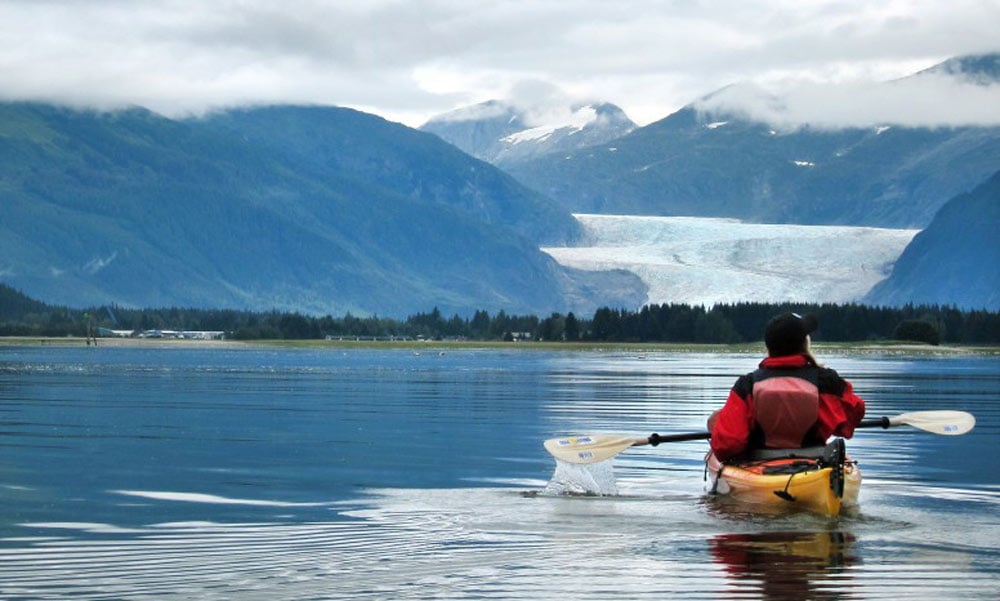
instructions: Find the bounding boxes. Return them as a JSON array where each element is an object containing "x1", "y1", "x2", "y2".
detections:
[{"x1": 0, "y1": 336, "x2": 1000, "y2": 356}]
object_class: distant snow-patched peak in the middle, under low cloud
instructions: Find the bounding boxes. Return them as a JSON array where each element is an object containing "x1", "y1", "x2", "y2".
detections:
[{"x1": 420, "y1": 100, "x2": 636, "y2": 166}]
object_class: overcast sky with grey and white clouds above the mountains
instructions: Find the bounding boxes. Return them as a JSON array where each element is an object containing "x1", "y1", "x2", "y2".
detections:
[{"x1": 0, "y1": 0, "x2": 1000, "y2": 126}]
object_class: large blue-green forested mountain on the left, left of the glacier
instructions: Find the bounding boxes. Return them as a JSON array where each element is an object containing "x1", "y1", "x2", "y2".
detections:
[{"x1": 0, "y1": 103, "x2": 640, "y2": 315}]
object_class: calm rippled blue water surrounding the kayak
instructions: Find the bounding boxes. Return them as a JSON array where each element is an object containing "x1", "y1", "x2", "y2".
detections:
[{"x1": 0, "y1": 347, "x2": 1000, "y2": 599}]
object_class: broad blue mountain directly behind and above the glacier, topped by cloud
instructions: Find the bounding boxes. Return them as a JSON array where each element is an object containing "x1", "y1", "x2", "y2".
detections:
[{"x1": 504, "y1": 54, "x2": 1000, "y2": 228}]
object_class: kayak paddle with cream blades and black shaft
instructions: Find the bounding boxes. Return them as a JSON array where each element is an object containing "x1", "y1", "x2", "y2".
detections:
[{"x1": 545, "y1": 411, "x2": 976, "y2": 464}]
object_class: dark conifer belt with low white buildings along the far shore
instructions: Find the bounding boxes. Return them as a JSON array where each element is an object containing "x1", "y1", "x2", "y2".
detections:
[{"x1": 0, "y1": 284, "x2": 1000, "y2": 353}]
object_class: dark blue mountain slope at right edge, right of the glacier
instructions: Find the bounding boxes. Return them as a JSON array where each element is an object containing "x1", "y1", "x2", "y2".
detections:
[{"x1": 864, "y1": 171, "x2": 1000, "y2": 311}]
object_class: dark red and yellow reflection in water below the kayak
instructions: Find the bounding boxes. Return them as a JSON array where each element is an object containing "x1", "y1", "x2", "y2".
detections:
[{"x1": 710, "y1": 531, "x2": 854, "y2": 601}]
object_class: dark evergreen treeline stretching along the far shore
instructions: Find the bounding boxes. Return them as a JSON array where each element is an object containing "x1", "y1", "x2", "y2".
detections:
[{"x1": 0, "y1": 284, "x2": 1000, "y2": 344}]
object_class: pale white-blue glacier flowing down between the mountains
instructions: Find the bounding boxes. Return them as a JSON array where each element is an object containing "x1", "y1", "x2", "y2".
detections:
[{"x1": 542, "y1": 214, "x2": 920, "y2": 306}]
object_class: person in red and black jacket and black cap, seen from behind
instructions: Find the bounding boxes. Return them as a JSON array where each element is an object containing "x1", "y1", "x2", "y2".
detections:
[{"x1": 708, "y1": 313, "x2": 865, "y2": 462}]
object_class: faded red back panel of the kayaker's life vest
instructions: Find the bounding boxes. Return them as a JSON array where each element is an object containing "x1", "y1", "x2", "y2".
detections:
[{"x1": 752, "y1": 367, "x2": 819, "y2": 449}]
